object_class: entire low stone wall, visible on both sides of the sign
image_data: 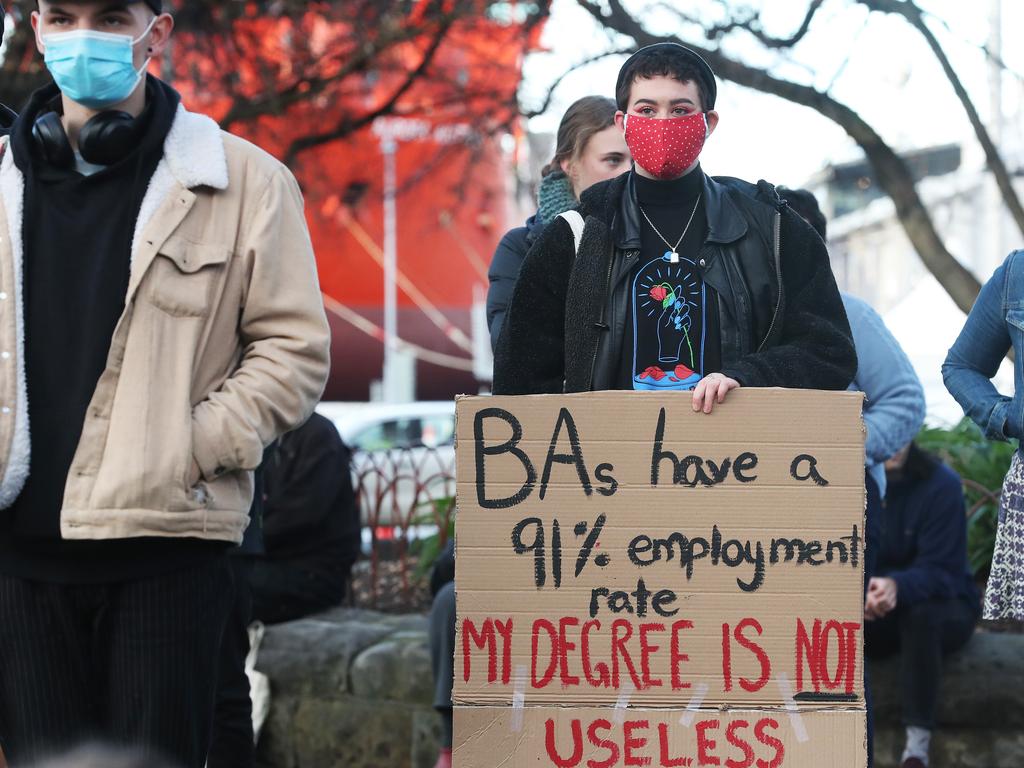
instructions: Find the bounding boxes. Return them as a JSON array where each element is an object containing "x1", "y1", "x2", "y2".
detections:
[{"x1": 251, "y1": 608, "x2": 1024, "y2": 768}]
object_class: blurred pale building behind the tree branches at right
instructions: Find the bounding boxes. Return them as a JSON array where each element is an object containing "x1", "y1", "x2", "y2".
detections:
[{"x1": 808, "y1": 138, "x2": 1024, "y2": 424}]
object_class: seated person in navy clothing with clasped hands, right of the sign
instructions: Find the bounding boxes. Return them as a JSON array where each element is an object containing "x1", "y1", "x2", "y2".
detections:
[{"x1": 864, "y1": 442, "x2": 981, "y2": 768}]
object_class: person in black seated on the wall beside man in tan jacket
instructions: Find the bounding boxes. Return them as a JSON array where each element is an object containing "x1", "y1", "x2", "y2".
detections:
[{"x1": 249, "y1": 414, "x2": 361, "y2": 624}]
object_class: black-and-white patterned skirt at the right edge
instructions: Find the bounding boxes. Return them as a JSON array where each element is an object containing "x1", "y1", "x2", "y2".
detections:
[{"x1": 984, "y1": 452, "x2": 1024, "y2": 621}]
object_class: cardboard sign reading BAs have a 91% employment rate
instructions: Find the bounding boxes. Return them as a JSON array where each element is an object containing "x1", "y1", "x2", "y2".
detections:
[{"x1": 454, "y1": 389, "x2": 864, "y2": 766}]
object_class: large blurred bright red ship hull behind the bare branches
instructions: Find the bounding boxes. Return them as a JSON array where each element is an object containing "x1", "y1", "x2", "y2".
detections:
[{"x1": 172, "y1": 0, "x2": 542, "y2": 401}]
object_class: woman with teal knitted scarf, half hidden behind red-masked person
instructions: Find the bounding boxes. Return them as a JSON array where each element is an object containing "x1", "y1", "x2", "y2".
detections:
[{"x1": 487, "y1": 96, "x2": 632, "y2": 349}]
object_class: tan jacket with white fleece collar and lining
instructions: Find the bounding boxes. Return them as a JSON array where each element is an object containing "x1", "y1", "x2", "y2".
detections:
[{"x1": 0, "y1": 108, "x2": 329, "y2": 542}]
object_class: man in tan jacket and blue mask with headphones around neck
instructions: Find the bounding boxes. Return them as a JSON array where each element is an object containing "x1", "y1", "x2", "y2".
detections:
[{"x1": 0, "y1": 0, "x2": 329, "y2": 768}]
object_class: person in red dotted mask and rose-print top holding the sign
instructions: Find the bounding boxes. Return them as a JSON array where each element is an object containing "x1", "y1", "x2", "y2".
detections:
[{"x1": 494, "y1": 43, "x2": 856, "y2": 405}]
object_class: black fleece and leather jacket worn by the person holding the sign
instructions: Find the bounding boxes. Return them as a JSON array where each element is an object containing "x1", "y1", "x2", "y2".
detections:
[{"x1": 494, "y1": 173, "x2": 857, "y2": 394}]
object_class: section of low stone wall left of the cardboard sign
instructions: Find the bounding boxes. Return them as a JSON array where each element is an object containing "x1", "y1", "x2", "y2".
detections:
[{"x1": 256, "y1": 608, "x2": 440, "y2": 768}]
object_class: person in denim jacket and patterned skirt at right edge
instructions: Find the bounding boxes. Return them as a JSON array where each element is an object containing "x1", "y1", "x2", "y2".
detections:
[{"x1": 942, "y1": 251, "x2": 1024, "y2": 620}]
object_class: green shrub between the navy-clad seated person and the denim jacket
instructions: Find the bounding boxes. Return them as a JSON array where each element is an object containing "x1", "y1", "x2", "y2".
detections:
[{"x1": 918, "y1": 419, "x2": 1017, "y2": 577}]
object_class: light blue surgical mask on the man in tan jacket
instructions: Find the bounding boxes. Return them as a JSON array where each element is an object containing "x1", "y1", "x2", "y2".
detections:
[{"x1": 42, "y1": 18, "x2": 157, "y2": 110}]
